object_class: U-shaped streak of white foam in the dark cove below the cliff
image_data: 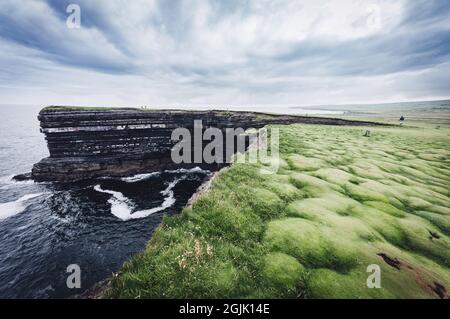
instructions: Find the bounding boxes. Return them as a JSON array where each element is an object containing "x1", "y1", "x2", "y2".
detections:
[{"x1": 94, "y1": 178, "x2": 184, "y2": 221}]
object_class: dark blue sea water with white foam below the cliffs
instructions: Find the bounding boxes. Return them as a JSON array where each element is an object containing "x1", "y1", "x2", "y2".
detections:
[{"x1": 0, "y1": 106, "x2": 208, "y2": 298}]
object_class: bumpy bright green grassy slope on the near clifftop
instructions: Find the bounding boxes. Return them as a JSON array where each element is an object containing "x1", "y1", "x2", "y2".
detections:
[{"x1": 106, "y1": 125, "x2": 450, "y2": 298}]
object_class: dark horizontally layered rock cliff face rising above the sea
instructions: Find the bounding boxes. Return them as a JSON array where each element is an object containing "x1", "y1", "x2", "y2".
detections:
[{"x1": 31, "y1": 107, "x2": 384, "y2": 182}]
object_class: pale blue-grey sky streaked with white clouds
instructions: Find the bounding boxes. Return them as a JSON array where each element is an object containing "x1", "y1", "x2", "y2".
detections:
[{"x1": 0, "y1": 0, "x2": 450, "y2": 108}]
